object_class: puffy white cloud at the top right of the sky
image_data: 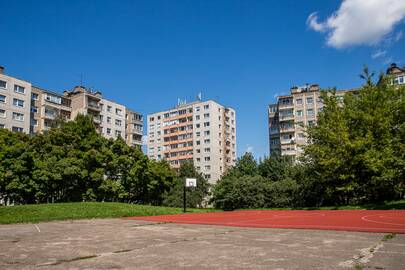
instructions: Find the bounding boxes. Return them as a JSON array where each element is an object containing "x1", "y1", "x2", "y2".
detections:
[{"x1": 307, "y1": 0, "x2": 405, "y2": 48}]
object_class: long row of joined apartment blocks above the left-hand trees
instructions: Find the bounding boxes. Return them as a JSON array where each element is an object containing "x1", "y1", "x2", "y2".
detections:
[{"x1": 0, "y1": 68, "x2": 143, "y2": 148}]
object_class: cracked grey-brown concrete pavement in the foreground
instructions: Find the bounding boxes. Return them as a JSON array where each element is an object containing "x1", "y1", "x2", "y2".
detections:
[{"x1": 0, "y1": 219, "x2": 405, "y2": 270}]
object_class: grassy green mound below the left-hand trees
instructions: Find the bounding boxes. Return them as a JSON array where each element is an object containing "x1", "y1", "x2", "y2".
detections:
[{"x1": 0, "y1": 202, "x2": 214, "y2": 224}]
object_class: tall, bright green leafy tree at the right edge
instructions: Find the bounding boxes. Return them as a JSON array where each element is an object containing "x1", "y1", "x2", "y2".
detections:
[{"x1": 303, "y1": 72, "x2": 405, "y2": 204}]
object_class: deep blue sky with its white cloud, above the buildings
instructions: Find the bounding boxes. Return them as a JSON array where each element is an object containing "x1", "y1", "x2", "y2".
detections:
[{"x1": 0, "y1": 0, "x2": 405, "y2": 157}]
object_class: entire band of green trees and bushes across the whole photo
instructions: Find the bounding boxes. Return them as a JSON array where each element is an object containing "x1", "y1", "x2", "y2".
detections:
[{"x1": 0, "y1": 72, "x2": 405, "y2": 210}]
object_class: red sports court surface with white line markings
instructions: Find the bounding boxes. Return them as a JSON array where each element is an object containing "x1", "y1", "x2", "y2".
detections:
[{"x1": 128, "y1": 210, "x2": 405, "y2": 233}]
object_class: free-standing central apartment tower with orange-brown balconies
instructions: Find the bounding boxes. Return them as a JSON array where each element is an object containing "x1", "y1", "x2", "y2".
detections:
[{"x1": 147, "y1": 100, "x2": 236, "y2": 183}]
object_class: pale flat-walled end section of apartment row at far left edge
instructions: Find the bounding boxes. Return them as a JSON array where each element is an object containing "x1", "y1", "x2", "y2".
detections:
[{"x1": 0, "y1": 67, "x2": 32, "y2": 133}]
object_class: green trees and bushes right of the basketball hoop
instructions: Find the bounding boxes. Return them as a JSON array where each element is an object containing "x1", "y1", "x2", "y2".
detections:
[{"x1": 212, "y1": 69, "x2": 405, "y2": 209}]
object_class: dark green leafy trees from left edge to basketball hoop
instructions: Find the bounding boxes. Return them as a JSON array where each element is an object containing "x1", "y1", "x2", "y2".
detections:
[{"x1": 0, "y1": 115, "x2": 208, "y2": 207}]
